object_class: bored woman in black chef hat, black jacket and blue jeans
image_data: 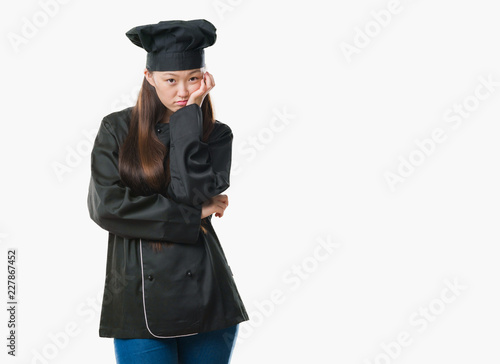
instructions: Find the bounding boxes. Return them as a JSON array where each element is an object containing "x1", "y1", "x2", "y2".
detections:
[{"x1": 88, "y1": 19, "x2": 248, "y2": 364}]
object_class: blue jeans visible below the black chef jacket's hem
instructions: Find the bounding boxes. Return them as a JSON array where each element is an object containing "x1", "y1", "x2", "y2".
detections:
[{"x1": 114, "y1": 324, "x2": 239, "y2": 364}]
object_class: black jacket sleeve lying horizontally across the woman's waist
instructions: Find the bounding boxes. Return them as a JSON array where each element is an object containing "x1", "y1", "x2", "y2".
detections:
[{"x1": 87, "y1": 119, "x2": 201, "y2": 244}]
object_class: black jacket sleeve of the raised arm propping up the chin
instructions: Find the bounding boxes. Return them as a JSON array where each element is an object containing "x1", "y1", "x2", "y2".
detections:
[{"x1": 167, "y1": 104, "x2": 233, "y2": 205}]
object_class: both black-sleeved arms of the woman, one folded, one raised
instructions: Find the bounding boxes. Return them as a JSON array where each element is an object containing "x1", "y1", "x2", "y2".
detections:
[{"x1": 87, "y1": 104, "x2": 233, "y2": 243}]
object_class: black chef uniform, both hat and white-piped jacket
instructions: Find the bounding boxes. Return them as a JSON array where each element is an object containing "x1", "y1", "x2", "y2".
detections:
[{"x1": 87, "y1": 19, "x2": 249, "y2": 338}]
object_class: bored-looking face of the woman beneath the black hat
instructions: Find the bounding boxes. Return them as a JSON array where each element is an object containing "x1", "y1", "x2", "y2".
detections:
[{"x1": 144, "y1": 68, "x2": 204, "y2": 113}]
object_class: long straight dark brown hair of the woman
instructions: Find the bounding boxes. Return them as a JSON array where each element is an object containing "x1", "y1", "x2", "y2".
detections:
[{"x1": 118, "y1": 72, "x2": 215, "y2": 251}]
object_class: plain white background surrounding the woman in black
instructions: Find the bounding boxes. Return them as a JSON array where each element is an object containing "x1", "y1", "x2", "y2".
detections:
[{"x1": 0, "y1": 0, "x2": 500, "y2": 364}]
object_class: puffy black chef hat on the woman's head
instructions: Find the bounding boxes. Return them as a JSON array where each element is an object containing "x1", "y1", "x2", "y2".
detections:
[{"x1": 125, "y1": 19, "x2": 217, "y2": 71}]
